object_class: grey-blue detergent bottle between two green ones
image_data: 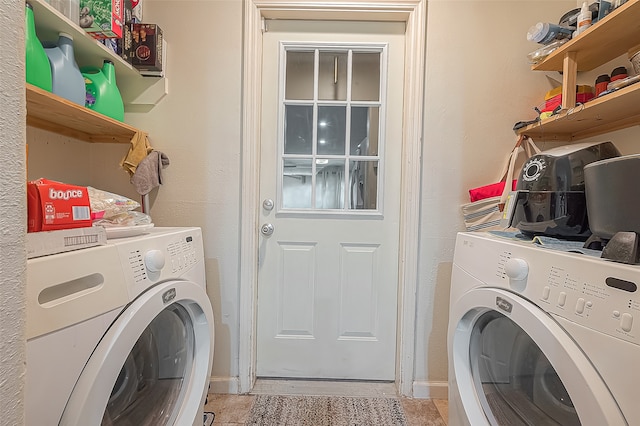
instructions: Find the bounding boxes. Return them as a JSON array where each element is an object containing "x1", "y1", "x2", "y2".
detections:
[{"x1": 44, "y1": 33, "x2": 86, "y2": 106}]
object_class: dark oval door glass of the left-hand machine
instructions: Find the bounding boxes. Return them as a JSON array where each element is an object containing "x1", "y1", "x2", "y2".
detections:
[{"x1": 102, "y1": 303, "x2": 195, "y2": 426}]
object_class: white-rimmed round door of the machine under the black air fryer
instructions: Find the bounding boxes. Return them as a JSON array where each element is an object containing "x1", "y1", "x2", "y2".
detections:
[{"x1": 450, "y1": 288, "x2": 627, "y2": 426}]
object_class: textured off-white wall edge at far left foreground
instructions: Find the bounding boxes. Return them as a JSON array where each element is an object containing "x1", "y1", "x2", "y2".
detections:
[{"x1": 0, "y1": 0, "x2": 27, "y2": 425}]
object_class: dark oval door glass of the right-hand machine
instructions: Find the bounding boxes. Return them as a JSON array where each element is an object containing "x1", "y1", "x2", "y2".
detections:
[{"x1": 469, "y1": 311, "x2": 580, "y2": 426}]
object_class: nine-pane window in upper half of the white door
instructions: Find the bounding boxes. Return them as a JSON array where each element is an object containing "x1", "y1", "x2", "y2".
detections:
[{"x1": 279, "y1": 45, "x2": 386, "y2": 213}]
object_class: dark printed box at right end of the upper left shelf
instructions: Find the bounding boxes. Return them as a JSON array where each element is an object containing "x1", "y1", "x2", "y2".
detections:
[{"x1": 131, "y1": 23, "x2": 162, "y2": 71}]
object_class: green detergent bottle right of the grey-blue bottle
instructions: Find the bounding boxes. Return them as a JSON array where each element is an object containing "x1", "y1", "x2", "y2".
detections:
[{"x1": 82, "y1": 60, "x2": 124, "y2": 121}]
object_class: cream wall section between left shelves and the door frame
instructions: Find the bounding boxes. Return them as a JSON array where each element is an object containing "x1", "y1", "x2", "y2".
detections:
[{"x1": 127, "y1": 0, "x2": 247, "y2": 390}]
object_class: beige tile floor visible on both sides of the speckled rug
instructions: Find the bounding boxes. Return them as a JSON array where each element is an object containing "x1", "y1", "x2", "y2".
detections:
[{"x1": 205, "y1": 394, "x2": 448, "y2": 426}]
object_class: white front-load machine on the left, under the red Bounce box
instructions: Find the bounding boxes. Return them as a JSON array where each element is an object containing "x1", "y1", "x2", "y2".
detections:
[{"x1": 25, "y1": 227, "x2": 214, "y2": 426}]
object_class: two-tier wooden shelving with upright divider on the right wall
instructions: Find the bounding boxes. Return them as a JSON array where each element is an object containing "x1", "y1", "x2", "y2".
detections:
[{"x1": 517, "y1": 0, "x2": 640, "y2": 141}]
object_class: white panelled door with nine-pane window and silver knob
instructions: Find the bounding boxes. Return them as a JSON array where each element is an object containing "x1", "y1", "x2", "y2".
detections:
[{"x1": 256, "y1": 21, "x2": 405, "y2": 380}]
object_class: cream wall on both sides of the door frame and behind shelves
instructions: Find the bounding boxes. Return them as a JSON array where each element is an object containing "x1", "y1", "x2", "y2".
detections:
[{"x1": 18, "y1": 0, "x2": 638, "y2": 397}]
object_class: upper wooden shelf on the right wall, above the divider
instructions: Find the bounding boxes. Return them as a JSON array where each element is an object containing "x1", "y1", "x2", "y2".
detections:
[{"x1": 531, "y1": 0, "x2": 640, "y2": 71}]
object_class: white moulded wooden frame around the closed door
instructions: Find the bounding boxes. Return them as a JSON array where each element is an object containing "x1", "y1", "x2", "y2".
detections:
[{"x1": 238, "y1": 0, "x2": 427, "y2": 396}]
